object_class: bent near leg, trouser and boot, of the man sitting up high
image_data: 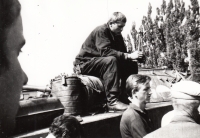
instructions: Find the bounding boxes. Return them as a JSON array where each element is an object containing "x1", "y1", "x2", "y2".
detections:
[{"x1": 80, "y1": 56, "x2": 127, "y2": 110}]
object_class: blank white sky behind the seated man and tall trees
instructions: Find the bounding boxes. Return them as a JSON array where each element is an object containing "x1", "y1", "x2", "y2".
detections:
[{"x1": 19, "y1": 0, "x2": 192, "y2": 86}]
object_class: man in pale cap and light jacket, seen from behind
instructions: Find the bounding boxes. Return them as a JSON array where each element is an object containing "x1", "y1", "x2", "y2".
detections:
[{"x1": 144, "y1": 81, "x2": 200, "y2": 138}]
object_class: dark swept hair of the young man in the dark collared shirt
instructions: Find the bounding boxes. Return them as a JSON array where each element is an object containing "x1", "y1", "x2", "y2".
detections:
[{"x1": 126, "y1": 74, "x2": 151, "y2": 97}]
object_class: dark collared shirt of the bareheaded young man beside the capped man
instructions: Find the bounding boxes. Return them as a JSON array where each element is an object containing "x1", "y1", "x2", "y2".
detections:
[{"x1": 120, "y1": 103, "x2": 152, "y2": 138}]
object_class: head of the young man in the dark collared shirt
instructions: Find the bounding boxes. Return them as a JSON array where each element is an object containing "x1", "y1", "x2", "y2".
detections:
[{"x1": 126, "y1": 74, "x2": 151, "y2": 110}]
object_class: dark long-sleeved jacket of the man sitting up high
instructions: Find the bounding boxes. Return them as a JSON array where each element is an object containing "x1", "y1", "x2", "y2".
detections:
[{"x1": 74, "y1": 24, "x2": 127, "y2": 65}]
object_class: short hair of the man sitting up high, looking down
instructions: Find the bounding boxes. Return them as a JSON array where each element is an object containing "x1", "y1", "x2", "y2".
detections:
[{"x1": 108, "y1": 12, "x2": 126, "y2": 24}]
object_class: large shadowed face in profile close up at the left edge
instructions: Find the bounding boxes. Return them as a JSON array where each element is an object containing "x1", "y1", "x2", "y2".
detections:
[{"x1": 0, "y1": 0, "x2": 27, "y2": 137}]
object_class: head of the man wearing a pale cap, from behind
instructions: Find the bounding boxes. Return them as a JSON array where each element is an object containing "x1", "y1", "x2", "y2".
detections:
[{"x1": 171, "y1": 81, "x2": 200, "y2": 120}]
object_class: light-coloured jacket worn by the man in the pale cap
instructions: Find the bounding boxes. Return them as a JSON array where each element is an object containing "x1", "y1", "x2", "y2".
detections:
[{"x1": 144, "y1": 115, "x2": 200, "y2": 138}]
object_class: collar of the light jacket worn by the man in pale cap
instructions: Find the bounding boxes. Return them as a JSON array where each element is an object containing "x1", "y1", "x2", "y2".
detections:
[{"x1": 171, "y1": 115, "x2": 196, "y2": 123}]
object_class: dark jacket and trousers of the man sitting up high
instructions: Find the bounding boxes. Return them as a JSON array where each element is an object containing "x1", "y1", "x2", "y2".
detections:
[{"x1": 74, "y1": 24, "x2": 138, "y2": 103}]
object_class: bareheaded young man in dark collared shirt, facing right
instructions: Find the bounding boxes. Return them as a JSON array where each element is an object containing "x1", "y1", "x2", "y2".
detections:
[{"x1": 120, "y1": 75, "x2": 151, "y2": 138}]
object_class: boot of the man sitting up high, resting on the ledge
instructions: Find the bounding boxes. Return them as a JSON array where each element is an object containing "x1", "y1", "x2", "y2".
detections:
[{"x1": 107, "y1": 92, "x2": 128, "y2": 112}]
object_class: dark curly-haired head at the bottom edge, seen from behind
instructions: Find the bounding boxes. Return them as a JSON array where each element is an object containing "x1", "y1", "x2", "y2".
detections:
[{"x1": 47, "y1": 115, "x2": 83, "y2": 138}]
